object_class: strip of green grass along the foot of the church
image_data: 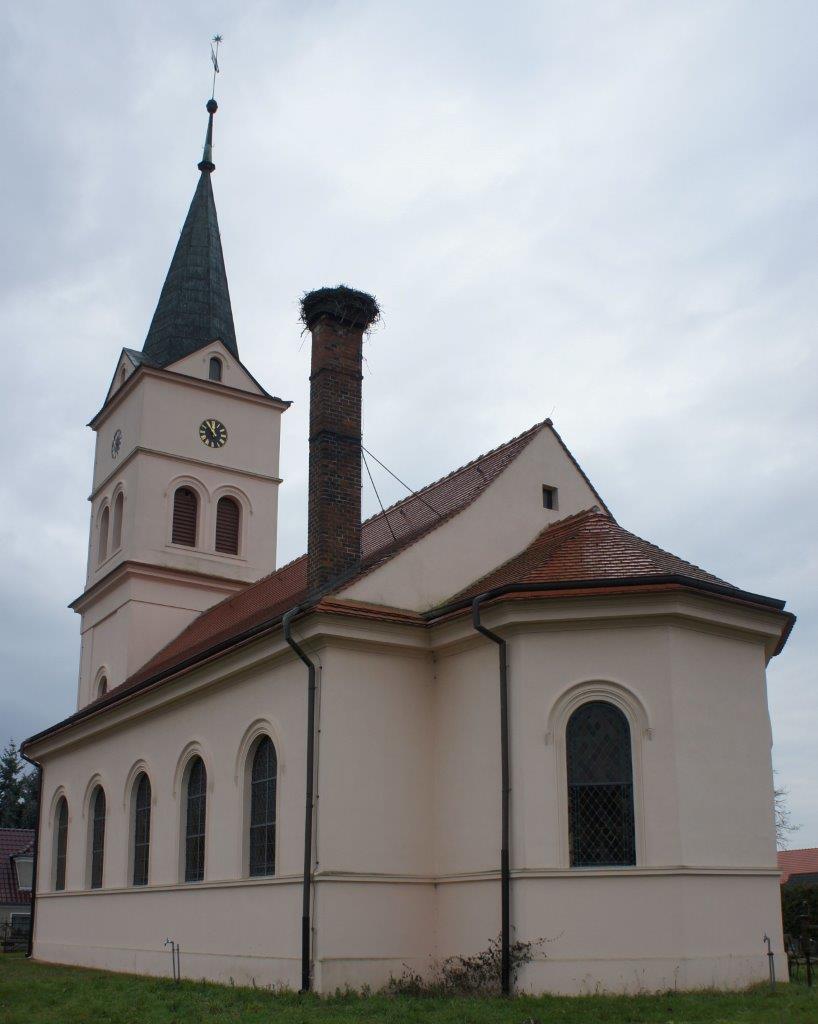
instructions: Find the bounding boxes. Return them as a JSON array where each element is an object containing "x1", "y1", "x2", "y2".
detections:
[{"x1": 0, "y1": 953, "x2": 818, "y2": 1024}]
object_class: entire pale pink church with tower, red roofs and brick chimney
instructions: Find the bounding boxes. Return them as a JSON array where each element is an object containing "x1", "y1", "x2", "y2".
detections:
[{"x1": 24, "y1": 100, "x2": 794, "y2": 993}]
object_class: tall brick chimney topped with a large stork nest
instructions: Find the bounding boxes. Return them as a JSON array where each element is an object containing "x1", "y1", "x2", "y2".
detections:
[{"x1": 301, "y1": 285, "x2": 379, "y2": 590}]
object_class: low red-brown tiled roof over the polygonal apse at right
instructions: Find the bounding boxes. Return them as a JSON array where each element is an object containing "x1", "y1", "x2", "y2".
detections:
[{"x1": 453, "y1": 509, "x2": 735, "y2": 603}]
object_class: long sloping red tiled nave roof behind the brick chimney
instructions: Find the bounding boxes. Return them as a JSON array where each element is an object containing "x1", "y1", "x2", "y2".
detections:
[{"x1": 103, "y1": 423, "x2": 550, "y2": 692}]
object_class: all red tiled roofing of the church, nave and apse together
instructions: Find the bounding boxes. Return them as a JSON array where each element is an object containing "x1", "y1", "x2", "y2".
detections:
[{"x1": 27, "y1": 420, "x2": 794, "y2": 743}]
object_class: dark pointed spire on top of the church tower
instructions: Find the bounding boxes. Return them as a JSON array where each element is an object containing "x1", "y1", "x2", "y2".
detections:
[{"x1": 142, "y1": 99, "x2": 239, "y2": 367}]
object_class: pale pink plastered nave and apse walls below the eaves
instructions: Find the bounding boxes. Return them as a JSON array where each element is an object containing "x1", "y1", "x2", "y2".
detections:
[{"x1": 30, "y1": 596, "x2": 782, "y2": 992}]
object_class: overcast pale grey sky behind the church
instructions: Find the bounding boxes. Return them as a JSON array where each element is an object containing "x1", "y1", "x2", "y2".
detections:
[{"x1": 0, "y1": 0, "x2": 818, "y2": 846}]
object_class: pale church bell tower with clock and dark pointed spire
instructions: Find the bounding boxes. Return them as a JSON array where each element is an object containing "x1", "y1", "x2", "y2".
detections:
[{"x1": 72, "y1": 99, "x2": 290, "y2": 708}]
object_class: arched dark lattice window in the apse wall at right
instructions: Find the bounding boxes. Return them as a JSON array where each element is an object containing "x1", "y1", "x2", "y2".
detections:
[{"x1": 565, "y1": 700, "x2": 636, "y2": 867}]
